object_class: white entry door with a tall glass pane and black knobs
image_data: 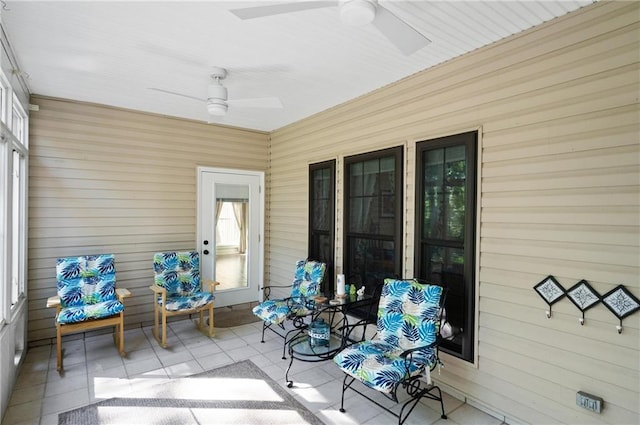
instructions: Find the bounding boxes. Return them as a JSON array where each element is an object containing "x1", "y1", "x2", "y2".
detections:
[{"x1": 196, "y1": 167, "x2": 264, "y2": 307}]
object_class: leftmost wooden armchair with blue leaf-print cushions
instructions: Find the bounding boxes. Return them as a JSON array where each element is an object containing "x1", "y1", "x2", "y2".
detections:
[{"x1": 47, "y1": 254, "x2": 131, "y2": 372}]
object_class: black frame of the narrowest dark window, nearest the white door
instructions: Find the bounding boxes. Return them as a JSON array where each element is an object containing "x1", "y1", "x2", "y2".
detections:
[{"x1": 307, "y1": 159, "x2": 336, "y2": 297}]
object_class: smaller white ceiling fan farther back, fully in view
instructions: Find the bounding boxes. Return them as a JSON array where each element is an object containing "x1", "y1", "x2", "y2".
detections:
[{"x1": 149, "y1": 67, "x2": 283, "y2": 117}]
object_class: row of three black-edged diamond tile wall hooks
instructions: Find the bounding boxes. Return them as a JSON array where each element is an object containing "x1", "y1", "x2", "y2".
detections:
[{"x1": 533, "y1": 275, "x2": 640, "y2": 334}]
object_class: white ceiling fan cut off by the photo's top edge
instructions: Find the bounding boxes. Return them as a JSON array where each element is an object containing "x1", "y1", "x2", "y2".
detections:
[{"x1": 230, "y1": 0, "x2": 431, "y2": 56}]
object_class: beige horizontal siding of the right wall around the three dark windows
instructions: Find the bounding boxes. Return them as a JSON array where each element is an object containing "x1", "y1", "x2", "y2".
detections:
[{"x1": 269, "y1": 2, "x2": 640, "y2": 424}]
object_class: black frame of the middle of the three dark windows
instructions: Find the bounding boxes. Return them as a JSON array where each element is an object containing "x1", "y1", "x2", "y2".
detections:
[{"x1": 342, "y1": 146, "x2": 404, "y2": 320}]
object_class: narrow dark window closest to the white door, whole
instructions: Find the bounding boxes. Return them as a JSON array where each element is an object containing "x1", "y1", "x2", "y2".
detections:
[{"x1": 308, "y1": 160, "x2": 336, "y2": 296}]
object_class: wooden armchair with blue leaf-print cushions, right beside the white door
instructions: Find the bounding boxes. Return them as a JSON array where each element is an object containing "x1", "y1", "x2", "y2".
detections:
[{"x1": 149, "y1": 251, "x2": 218, "y2": 348}]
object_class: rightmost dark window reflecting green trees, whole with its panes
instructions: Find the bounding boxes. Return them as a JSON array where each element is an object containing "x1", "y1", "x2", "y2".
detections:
[{"x1": 415, "y1": 132, "x2": 477, "y2": 361}]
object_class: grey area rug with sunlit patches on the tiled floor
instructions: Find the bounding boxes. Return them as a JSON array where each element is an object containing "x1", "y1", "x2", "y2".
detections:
[{"x1": 58, "y1": 360, "x2": 323, "y2": 425}]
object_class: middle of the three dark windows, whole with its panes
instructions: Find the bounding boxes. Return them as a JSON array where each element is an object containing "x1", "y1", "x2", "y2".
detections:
[{"x1": 344, "y1": 146, "x2": 403, "y2": 314}]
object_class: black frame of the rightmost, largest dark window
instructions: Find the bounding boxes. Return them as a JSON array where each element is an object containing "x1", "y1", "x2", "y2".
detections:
[{"x1": 414, "y1": 131, "x2": 478, "y2": 362}]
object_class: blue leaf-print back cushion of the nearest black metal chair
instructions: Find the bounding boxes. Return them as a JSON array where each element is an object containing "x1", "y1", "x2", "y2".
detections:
[{"x1": 376, "y1": 279, "x2": 442, "y2": 350}]
